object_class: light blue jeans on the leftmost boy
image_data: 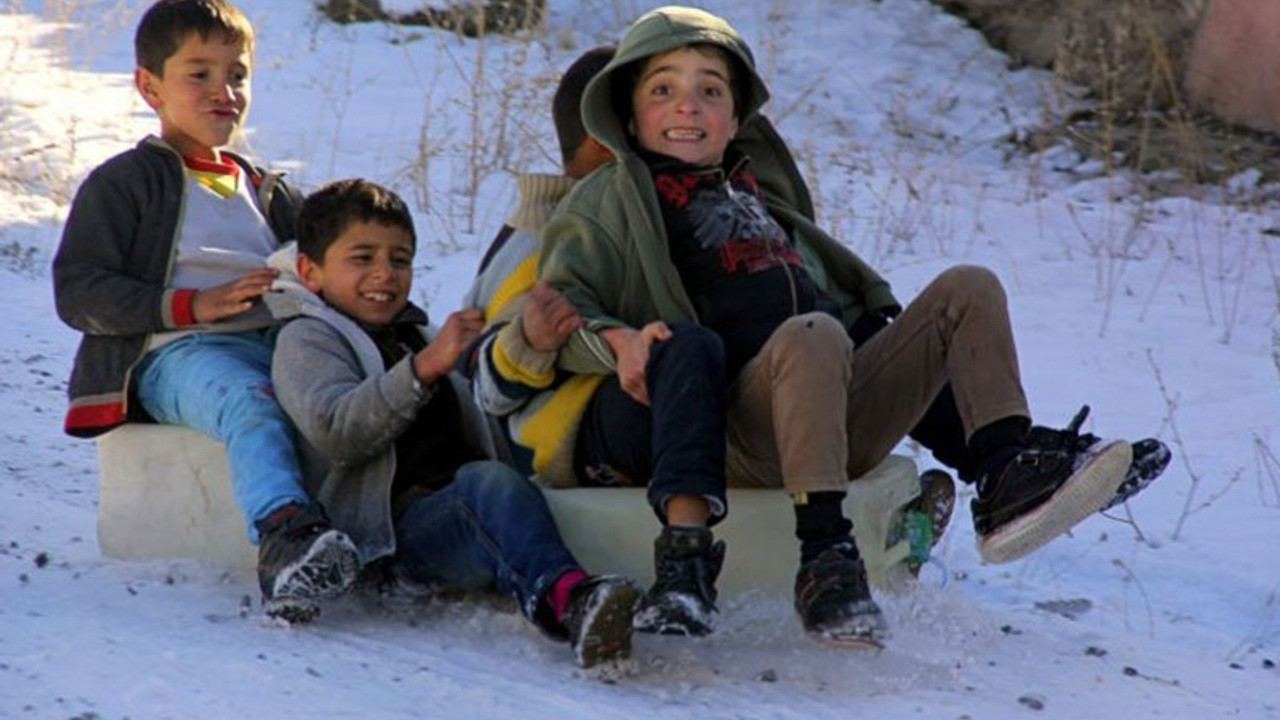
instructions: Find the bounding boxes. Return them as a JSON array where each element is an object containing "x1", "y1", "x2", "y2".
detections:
[{"x1": 134, "y1": 331, "x2": 310, "y2": 544}]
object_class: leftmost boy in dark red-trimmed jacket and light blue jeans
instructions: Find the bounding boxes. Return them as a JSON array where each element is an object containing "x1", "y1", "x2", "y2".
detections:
[{"x1": 54, "y1": 0, "x2": 356, "y2": 620}]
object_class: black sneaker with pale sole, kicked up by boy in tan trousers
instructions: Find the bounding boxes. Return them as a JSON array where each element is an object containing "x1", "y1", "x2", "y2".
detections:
[{"x1": 972, "y1": 415, "x2": 1133, "y2": 564}]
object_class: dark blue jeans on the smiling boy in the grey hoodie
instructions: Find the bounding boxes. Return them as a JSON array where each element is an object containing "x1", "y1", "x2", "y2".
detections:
[{"x1": 396, "y1": 460, "x2": 580, "y2": 625}]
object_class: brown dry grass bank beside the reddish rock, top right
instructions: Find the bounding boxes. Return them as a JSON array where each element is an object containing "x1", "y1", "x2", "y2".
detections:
[{"x1": 934, "y1": 0, "x2": 1280, "y2": 195}]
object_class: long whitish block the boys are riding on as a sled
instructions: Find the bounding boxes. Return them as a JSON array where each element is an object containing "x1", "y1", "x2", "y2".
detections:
[{"x1": 97, "y1": 425, "x2": 919, "y2": 593}]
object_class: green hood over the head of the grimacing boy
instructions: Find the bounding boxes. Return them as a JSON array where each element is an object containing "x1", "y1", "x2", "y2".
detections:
[{"x1": 582, "y1": 5, "x2": 769, "y2": 155}]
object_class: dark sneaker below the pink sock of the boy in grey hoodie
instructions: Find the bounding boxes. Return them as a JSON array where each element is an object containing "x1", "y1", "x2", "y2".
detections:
[{"x1": 564, "y1": 575, "x2": 640, "y2": 667}]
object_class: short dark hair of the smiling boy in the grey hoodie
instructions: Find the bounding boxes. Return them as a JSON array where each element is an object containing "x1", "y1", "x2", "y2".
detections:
[{"x1": 298, "y1": 178, "x2": 417, "y2": 265}]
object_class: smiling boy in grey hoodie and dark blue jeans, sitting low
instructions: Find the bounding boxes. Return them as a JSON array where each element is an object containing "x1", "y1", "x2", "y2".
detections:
[{"x1": 269, "y1": 179, "x2": 639, "y2": 666}]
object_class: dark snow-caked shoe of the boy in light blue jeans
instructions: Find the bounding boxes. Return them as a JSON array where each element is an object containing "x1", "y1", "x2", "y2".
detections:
[{"x1": 257, "y1": 503, "x2": 360, "y2": 623}]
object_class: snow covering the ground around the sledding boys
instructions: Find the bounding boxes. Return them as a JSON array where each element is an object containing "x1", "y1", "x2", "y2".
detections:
[{"x1": 0, "y1": 0, "x2": 1280, "y2": 720}]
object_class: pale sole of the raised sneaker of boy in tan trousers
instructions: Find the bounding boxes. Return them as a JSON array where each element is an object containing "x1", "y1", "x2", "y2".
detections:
[{"x1": 978, "y1": 441, "x2": 1133, "y2": 565}]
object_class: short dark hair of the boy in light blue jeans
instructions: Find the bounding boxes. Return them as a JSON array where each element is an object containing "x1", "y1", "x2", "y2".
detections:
[{"x1": 133, "y1": 0, "x2": 253, "y2": 76}]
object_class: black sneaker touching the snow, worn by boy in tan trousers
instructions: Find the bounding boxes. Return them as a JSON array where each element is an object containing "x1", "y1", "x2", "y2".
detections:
[{"x1": 795, "y1": 542, "x2": 888, "y2": 648}]
